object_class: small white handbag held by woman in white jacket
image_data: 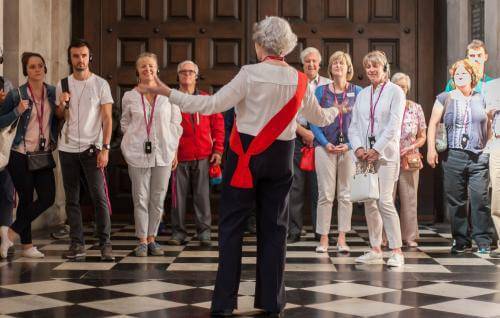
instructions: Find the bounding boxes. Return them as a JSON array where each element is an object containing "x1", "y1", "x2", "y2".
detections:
[{"x1": 351, "y1": 162, "x2": 380, "y2": 202}]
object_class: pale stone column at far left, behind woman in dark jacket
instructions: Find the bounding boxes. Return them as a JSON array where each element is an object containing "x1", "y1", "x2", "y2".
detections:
[{"x1": 0, "y1": 0, "x2": 71, "y2": 229}]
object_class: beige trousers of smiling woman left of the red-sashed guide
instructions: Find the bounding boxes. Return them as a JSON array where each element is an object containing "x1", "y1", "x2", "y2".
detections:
[{"x1": 128, "y1": 166, "x2": 171, "y2": 238}]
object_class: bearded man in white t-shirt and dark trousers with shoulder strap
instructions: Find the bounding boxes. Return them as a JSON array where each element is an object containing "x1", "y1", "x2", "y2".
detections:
[{"x1": 56, "y1": 40, "x2": 114, "y2": 261}]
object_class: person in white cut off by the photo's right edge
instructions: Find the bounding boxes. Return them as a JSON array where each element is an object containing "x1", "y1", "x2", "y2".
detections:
[{"x1": 483, "y1": 78, "x2": 500, "y2": 258}]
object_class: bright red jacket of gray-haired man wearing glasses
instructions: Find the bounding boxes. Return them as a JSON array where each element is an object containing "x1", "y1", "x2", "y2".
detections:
[{"x1": 177, "y1": 91, "x2": 224, "y2": 162}]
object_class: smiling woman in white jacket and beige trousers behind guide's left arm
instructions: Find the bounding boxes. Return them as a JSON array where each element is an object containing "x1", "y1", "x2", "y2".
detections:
[{"x1": 120, "y1": 53, "x2": 182, "y2": 256}]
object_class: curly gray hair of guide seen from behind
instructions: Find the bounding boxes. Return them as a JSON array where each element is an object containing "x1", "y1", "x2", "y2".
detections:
[{"x1": 252, "y1": 16, "x2": 297, "y2": 56}]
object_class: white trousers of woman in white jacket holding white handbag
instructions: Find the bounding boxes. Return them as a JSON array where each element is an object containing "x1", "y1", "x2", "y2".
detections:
[{"x1": 365, "y1": 162, "x2": 403, "y2": 249}]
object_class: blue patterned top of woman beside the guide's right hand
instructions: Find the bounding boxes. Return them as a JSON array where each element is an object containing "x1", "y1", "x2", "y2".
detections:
[{"x1": 309, "y1": 83, "x2": 361, "y2": 146}]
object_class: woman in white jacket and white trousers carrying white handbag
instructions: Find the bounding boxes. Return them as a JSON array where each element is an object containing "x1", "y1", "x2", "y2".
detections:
[{"x1": 349, "y1": 51, "x2": 406, "y2": 266}]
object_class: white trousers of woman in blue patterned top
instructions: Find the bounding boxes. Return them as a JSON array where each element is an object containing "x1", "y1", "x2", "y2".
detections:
[{"x1": 314, "y1": 146, "x2": 354, "y2": 235}]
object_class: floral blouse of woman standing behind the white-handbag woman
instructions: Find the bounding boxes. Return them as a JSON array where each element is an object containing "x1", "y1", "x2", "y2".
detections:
[{"x1": 399, "y1": 100, "x2": 427, "y2": 149}]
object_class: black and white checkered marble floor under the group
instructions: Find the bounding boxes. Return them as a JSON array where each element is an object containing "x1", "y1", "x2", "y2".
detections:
[{"x1": 0, "y1": 224, "x2": 500, "y2": 318}]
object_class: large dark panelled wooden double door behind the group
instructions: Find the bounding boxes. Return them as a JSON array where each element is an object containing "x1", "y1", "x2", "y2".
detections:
[{"x1": 82, "y1": 0, "x2": 434, "y2": 219}]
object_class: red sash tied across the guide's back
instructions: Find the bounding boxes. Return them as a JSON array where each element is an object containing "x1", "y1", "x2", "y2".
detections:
[{"x1": 229, "y1": 72, "x2": 307, "y2": 189}]
